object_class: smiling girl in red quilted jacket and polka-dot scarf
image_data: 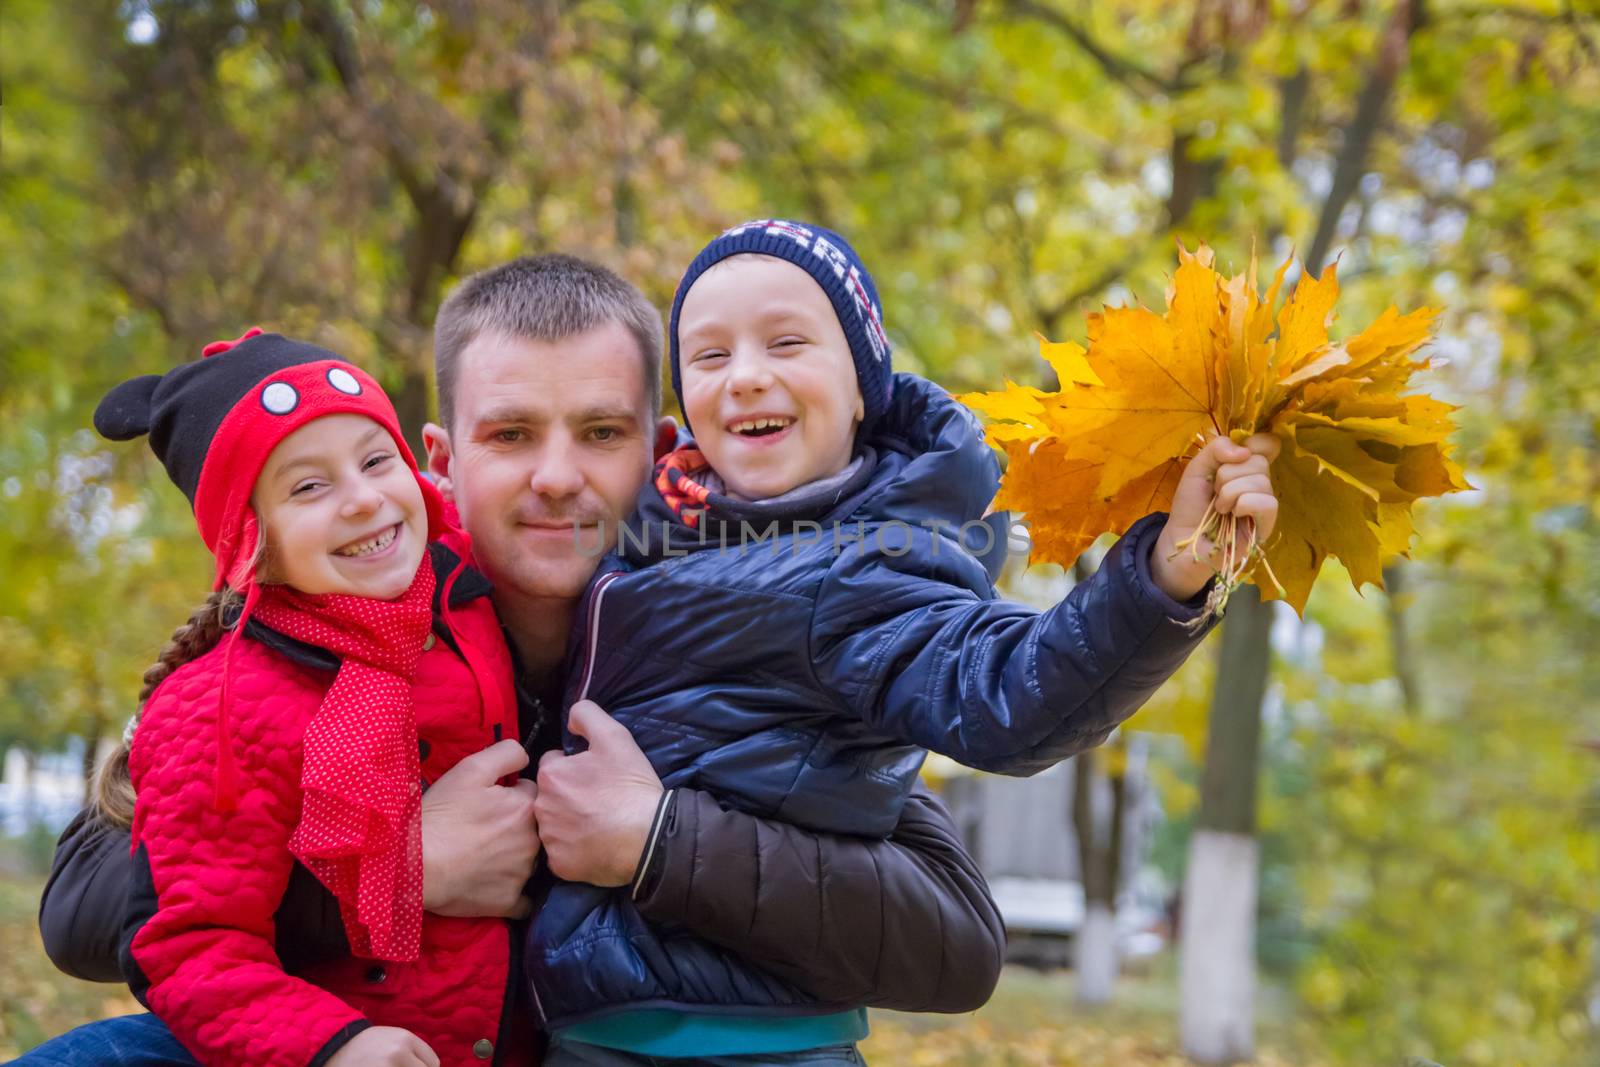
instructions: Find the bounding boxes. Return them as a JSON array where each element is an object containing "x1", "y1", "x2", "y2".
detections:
[{"x1": 94, "y1": 330, "x2": 531, "y2": 1067}]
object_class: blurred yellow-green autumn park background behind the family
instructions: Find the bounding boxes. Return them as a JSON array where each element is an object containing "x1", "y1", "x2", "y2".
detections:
[{"x1": 0, "y1": 0, "x2": 1600, "y2": 1067}]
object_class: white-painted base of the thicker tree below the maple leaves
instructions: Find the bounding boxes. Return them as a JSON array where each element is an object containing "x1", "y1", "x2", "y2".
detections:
[{"x1": 1179, "y1": 830, "x2": 1259, "y2": 1064}]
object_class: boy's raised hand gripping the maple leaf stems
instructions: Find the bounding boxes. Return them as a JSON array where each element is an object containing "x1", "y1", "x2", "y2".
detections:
[{"x1": 1150, "y1": 434, "x2": 1282, "y2": 600}]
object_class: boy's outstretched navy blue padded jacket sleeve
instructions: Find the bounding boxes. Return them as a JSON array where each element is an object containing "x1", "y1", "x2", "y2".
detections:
[{"x1": 811, "y1": 514, "x2": 1211, "y2": 774}]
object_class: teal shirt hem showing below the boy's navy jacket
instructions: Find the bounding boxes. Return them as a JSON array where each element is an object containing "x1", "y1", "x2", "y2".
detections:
[{"x1": 554, "y1": 1008, "x2": 867, "y2": 1056}]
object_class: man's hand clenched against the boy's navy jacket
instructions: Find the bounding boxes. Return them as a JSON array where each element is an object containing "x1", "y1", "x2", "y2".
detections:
[{"x1": 533, "y1": 701, "x2": 662, "y2": 886}]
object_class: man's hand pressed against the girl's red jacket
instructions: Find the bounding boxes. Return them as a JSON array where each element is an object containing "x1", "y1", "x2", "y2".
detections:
[{"x1": 422, "y1": 741, "x2": 539, "y2": 918}]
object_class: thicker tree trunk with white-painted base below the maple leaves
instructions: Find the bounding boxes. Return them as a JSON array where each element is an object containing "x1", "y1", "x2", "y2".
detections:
[{"x1": 1179, "y1": 585, "x2": 1272, "y2": 1064}]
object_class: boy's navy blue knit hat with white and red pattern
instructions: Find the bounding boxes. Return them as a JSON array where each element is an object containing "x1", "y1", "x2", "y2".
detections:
[{"x1": 667, "y1": 219, "x2": 894, "y2": 430}]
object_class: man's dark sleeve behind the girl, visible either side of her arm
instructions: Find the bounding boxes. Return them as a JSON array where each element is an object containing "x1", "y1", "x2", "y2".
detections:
[{"x1": 38, "y1": 808, "x2": 350, "y2": 982}]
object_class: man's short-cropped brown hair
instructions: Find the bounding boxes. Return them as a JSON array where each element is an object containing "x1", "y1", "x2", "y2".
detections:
[{"x1": 434, "y1": 254, "x2": 662, "y2": 430}]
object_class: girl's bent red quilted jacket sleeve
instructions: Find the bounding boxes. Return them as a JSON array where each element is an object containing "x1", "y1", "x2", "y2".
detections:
[{"x1": 122, "y1": 675, "x2": 368, "y2": 1067}]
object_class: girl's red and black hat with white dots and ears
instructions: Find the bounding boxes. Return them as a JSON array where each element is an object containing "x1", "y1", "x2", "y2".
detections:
[{"x1": 94, "y1": 330, "x2": 443, "y2": 589}]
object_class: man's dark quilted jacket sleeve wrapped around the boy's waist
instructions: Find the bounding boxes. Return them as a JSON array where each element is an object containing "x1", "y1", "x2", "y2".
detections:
[{"x1": 634, "y1": 787, "x2": 1005, "y2": 1013}]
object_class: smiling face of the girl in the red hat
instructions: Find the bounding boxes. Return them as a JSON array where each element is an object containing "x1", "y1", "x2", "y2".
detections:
[{"x1": 251, "y1": 414, "x2": 427, "y2": 600}]
